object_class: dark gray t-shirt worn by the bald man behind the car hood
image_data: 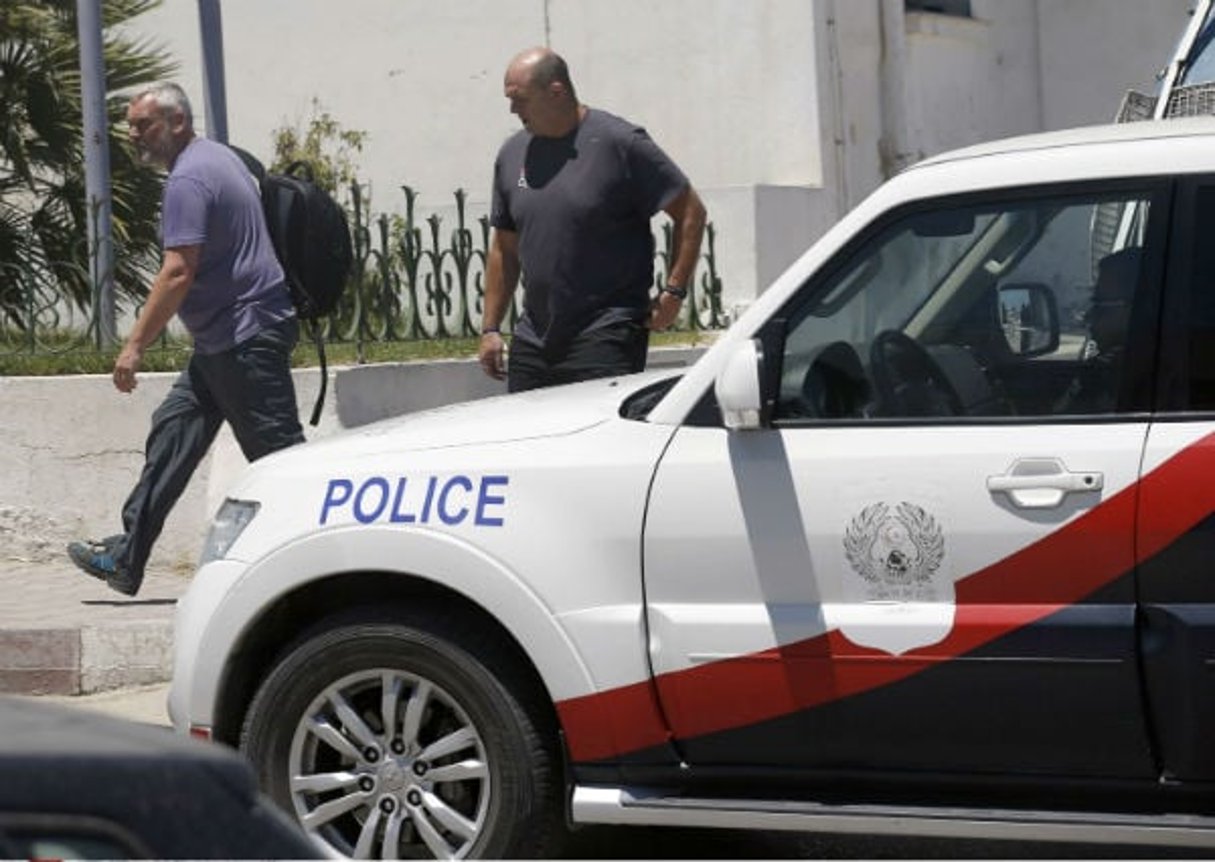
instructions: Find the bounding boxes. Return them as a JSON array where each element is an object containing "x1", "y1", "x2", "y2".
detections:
[{"x1": 490, "y1": 109, "x2": 689, "y2": 350}]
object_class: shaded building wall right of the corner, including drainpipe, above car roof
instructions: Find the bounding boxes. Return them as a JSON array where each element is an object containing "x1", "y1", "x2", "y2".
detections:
[{"x1": 815, "y1": 0, "x2": 1192, "y2": 208}]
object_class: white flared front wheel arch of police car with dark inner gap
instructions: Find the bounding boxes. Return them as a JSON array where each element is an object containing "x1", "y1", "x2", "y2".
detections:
[{"x1": 196, "y1": 528, "x2": 592, "y2": 745}]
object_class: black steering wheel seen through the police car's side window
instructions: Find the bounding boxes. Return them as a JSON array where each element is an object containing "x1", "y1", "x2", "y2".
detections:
[{"x1": 869, "y1": 329, "x2": 966, "y2": 416}]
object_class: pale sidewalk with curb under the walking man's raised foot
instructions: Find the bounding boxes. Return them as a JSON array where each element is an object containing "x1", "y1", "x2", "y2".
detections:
[{"x1": 0, "y1": 556, "x2": 190, "y2": 694}]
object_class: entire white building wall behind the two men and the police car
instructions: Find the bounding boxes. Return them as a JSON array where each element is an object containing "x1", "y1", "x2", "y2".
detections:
[{"x1": 120, "y1": 0, "x2": 1189, "y2": 308}]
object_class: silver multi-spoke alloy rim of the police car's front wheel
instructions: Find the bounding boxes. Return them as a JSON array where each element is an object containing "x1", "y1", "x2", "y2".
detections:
[{"x1": 288, "y1": 669, "x2": 493, "y2": 858}]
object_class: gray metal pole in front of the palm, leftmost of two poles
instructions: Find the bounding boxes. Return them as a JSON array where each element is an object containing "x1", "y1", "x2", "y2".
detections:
[{"x1": 77, "y1": 0, "x2": 118, "y2": 347}]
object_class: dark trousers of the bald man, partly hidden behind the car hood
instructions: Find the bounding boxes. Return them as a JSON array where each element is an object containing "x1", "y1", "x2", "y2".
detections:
[{"x1": 507, "y1": 321, "x2": 650, "y2": 391}]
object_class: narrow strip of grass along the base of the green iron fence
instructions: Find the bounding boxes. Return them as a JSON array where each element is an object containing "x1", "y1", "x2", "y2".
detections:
[{"x1": 0, "y1": 332, "x2": 718, "y2": 377}]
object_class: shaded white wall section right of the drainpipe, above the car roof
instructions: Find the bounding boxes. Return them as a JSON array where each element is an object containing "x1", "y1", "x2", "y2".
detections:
[{"x1": 904, "y1": 0, "x2": 1193, "y2": 156}]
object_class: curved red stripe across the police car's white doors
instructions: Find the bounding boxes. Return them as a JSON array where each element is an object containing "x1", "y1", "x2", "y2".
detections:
[{"x1": 558, "y1": 435, "x2": 1215, "y2": 761}]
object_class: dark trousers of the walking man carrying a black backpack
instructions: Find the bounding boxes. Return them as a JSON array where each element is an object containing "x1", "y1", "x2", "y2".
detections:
[{"x1": 111, "y1": 319, "x2": 304, "y2": 584}]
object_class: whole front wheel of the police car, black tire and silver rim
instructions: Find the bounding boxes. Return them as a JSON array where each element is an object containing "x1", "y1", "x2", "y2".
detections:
[{"x1": 241, "y1": 612, "x2": 561, "y2": 858}]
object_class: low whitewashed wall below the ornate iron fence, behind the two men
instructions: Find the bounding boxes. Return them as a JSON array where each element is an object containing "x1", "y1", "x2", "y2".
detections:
[{"x1": 0, "y1": 348, "x2": 702, "y2": 569}]
